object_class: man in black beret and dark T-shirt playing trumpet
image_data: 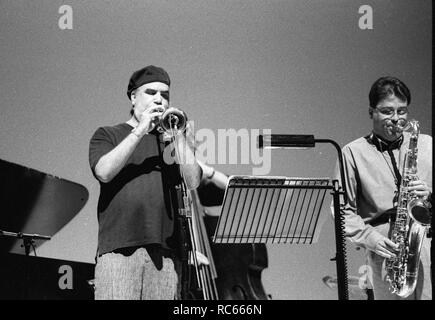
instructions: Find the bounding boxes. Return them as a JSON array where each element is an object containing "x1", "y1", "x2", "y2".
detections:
[{"x1": 89, "y1": 65, "x2": 202, "y2": 300}]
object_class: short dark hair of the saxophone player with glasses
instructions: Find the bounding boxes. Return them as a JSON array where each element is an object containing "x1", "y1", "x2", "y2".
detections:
[{"x1": 369, "y1": 76, "x2": 411, "y2": 108}]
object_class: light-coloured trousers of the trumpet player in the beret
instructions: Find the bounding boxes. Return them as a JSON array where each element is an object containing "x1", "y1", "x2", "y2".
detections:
[{"x1": 95, "y1": 247, "x2": 181, "y2": 300}]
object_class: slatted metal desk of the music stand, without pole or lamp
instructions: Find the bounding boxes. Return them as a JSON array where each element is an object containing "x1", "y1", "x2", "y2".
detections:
[{"x1": 214, "y1": 176, "x2": 333, "y2": 244}]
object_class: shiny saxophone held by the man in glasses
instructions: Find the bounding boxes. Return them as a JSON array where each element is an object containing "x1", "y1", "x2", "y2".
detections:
[{"x1": 385, "y1": 120, "x2": 432, "y2": 298}]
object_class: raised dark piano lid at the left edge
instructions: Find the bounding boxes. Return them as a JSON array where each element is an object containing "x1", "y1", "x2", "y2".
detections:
[{"x1": 0, "y1": 159, "x2": 89, "y2": 254}]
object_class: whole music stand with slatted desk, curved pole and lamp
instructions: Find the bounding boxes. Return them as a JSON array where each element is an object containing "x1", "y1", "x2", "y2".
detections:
[{"x1": 213, "y1": 134, "x2": 349, "y2": 300}]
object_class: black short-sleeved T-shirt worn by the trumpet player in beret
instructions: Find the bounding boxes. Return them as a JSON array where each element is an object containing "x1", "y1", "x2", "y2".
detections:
[{"x1": 89, "y1": 123, "x2": 180, "y2": 255}]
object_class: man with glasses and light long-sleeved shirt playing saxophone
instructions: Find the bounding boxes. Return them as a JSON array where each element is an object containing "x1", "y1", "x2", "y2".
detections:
[{"x1": 336, "y1": 76, "x2": 432, "y2": 300}]
